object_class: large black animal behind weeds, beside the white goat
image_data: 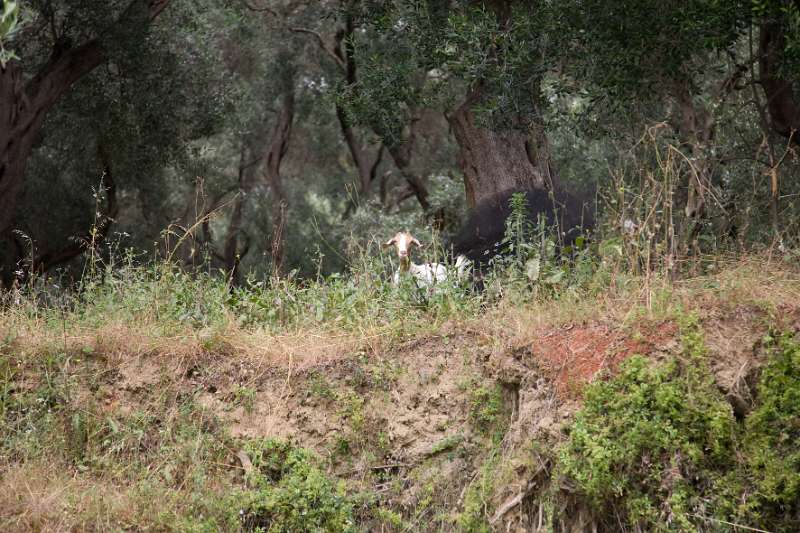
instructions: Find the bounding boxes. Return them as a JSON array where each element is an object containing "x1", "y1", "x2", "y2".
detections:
[{"x1": 452, "y1": 189, "x2": 594, "y2": 269}]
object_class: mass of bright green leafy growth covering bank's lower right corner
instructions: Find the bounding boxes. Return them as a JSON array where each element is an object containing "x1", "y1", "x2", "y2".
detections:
[{"x1": 557, "y1": 319, "x2": 800, "y2": 531}]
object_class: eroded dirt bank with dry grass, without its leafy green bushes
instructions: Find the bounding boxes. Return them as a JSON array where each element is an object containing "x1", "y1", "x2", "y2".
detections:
[{"x1": 0, "y1": 264, "x2": 800, "y2": 531}]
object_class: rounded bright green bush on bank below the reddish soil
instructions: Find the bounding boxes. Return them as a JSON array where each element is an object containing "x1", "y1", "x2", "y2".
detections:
[{"x1": 558, "y1": 350, "x2": 735, "y2": 530}]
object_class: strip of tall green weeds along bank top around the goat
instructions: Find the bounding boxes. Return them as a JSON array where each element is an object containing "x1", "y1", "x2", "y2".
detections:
[{"x1": 0, "y1": 196, "x2": 608, "y2": 342}]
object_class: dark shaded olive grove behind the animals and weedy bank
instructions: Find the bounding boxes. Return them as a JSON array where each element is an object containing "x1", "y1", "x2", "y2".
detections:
[{"x1": 0, "y1": 0, "x2": 800, "y2": 287}]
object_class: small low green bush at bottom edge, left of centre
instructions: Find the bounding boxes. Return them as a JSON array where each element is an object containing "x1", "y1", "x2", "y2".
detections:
[{"x1": 239, "y1": 439, "x2": 356, "y2": 533}]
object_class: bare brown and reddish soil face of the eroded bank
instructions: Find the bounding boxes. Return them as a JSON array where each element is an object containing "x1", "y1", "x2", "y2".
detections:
[{"x1": 76, "y1": 305, "x2": 788, "y2": 530}]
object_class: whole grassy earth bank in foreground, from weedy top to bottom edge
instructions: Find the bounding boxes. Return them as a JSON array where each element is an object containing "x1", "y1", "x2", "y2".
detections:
[{"x1": 0, "y1": 256, "x2": 800, "y2": 532}]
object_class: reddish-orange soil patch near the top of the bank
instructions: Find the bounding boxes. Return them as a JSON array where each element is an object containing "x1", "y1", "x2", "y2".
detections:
[{"x1": 532, "y1": 322, "x2": 678, "y2": 396}]
